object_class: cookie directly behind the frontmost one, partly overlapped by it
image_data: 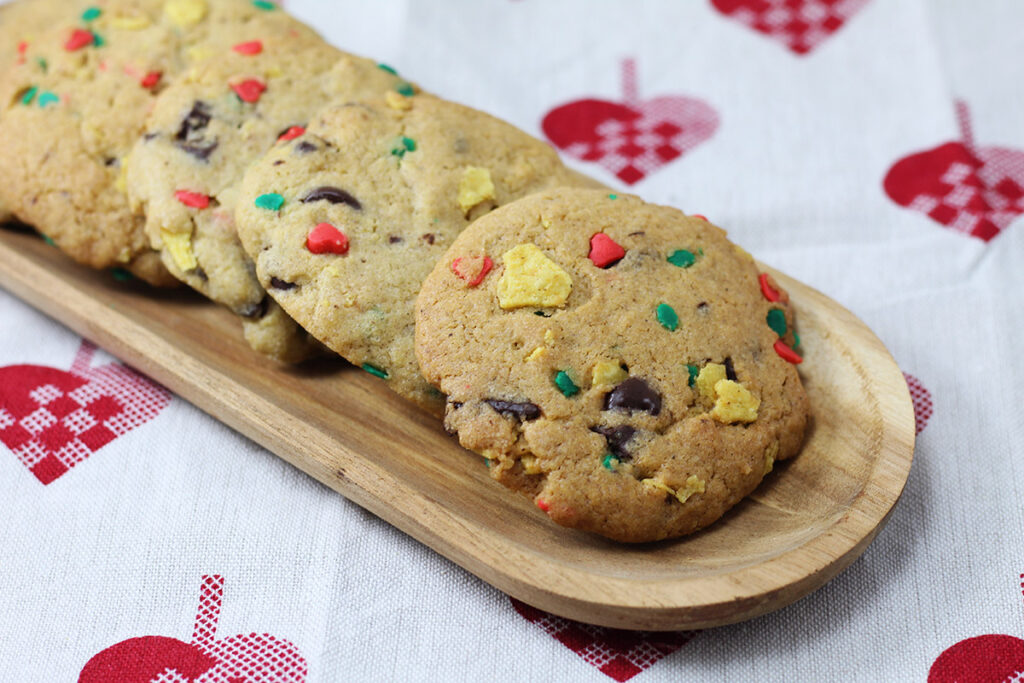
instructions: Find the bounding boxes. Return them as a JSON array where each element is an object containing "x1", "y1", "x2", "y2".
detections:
[{"x1": 236, "y1": 92, "x2": 593, "y2": 415}]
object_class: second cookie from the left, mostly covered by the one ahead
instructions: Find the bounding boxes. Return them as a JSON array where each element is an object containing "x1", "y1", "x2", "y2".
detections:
[{"x1": 126, "y1": 34, "x2": 412, "y2": 361}]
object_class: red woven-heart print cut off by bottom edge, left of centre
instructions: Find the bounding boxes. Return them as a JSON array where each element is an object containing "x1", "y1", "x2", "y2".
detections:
[{"x1": 78, "y1": 574, "x2": 308, "y2": 683}]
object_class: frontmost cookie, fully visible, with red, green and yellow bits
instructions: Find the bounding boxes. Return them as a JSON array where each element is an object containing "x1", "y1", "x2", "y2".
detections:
[{"x1": 416, "y1": 189, "x2": 808, "y2": 542}]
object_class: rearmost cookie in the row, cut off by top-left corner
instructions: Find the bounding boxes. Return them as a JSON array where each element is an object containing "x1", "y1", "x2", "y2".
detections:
[{"x1": 0, "y1": 0, "x2": 313, "y2": 284}]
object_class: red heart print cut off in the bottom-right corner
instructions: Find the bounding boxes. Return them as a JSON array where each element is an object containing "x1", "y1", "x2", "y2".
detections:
[{"x1": 928, "y1": 573, "x2": 1024, "y2": 683}]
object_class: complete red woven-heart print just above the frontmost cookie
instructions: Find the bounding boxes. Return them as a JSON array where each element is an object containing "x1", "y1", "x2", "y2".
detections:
[{"x1": 541, "y1": 59, "x2": 719, "y2": 185}]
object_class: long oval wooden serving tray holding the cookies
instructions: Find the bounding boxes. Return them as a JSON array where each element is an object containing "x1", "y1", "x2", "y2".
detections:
[{"x1": 0, "y1": 230, "x2": 914, "y2": 630}]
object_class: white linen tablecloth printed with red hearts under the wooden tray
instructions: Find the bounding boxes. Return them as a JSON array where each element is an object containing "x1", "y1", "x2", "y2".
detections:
[{"x1": 0, "y1": 0, "x2": 1024, "y2": 683}]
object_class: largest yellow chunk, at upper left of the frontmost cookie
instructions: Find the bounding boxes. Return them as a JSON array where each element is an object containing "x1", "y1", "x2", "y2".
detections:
[{"x1": 498, "y1": 244, "x2": 572, "y2": 310}]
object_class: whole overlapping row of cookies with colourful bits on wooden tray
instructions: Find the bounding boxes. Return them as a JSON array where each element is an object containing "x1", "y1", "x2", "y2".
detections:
[{"x1": 0, "y1": 0, "x2": 808, "y2": 542}]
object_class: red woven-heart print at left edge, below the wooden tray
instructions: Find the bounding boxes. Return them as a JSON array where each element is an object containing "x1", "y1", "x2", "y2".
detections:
[{"x1": 0, "y1": 341, "x2": 171, "y2": 484}]
